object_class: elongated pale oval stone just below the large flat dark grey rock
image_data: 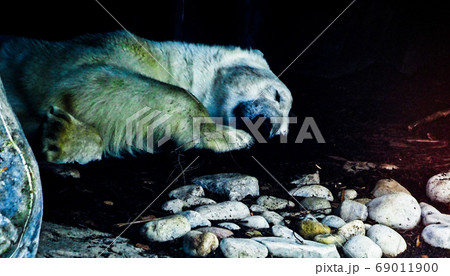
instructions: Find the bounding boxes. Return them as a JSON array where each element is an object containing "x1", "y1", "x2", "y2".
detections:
[{"x1": 195, "y1": 201, "x2": 250, "y2": 220}]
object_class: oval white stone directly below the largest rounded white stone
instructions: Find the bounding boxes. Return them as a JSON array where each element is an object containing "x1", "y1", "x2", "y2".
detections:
[{"x1": 367, "y1": 224, "x2": 407, "y2": 257}]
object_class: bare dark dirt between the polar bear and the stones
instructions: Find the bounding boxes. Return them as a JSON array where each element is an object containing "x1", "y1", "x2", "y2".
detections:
[{"x1": 42, "y1": 61, "x2": 450, "y2": 257}]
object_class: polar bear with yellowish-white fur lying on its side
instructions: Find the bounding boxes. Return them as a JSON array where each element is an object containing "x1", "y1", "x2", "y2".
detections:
[{"x1": 0, "y1": 32, "x2": 292, "y2": 164}]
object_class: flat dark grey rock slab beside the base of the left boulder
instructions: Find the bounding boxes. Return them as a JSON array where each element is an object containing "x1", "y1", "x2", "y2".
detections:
[{"x1": 36, "y1": 222, "x2": 155, "y2": 258}]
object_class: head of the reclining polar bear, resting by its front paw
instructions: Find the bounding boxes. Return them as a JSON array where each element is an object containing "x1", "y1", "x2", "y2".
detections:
[{"x1": 213, "y1": 53, "x2": 292, "y2": 138}]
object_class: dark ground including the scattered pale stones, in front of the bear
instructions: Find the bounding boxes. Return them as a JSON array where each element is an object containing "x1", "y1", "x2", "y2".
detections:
[{"x1": 36, "y1": 61, "x2": 450, "y2": 257}]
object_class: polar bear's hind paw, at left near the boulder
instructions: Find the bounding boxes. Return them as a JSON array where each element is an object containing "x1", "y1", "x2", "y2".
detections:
[{"x1": 42, "y1": 106, "x2": 104, "y2": 164}]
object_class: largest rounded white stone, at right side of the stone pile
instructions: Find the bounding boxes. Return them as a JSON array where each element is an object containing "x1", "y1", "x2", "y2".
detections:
[{"x1": 367, "y1": 193, "x2": 421, "y2": 230}]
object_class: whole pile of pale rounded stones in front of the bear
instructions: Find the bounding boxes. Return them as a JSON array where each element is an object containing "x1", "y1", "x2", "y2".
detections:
[{"x1": 141, "y1": 172, "x2": 450, "y2": 258}]
